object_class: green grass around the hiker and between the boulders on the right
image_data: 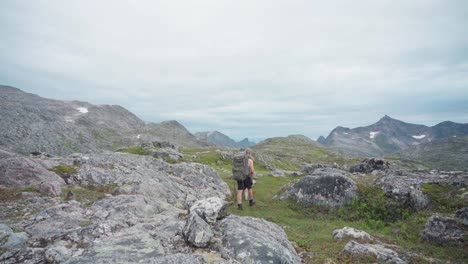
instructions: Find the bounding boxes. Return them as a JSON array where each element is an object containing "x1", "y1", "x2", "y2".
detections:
[{"x1": 182, "y1": 148, "x2": 467, "y2": 263}]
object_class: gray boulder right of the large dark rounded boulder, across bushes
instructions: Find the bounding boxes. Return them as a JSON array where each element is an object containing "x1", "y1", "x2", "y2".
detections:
[{"x1": 376, "y1": 174, "x2": 429, "y2": 210}]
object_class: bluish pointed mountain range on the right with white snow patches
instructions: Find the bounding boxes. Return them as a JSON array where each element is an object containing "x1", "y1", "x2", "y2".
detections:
[{"x1": 320, "y1": 116, "x2": 468, "y2": 156}]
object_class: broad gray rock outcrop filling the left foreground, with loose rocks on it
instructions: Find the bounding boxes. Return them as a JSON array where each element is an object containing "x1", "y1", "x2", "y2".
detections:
[{"x1": 0, "y1": 152, "x2": 300, "y2": 264}]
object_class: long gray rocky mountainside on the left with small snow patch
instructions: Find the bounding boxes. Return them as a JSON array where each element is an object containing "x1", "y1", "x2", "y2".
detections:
[{"x1": 0, "y1": 86, "x2": 205, "y2": 155}]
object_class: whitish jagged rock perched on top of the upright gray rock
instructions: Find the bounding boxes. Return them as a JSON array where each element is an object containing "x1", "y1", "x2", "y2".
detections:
[{"x1": 190, "y1": 197, "x2": 231, "y2": 224}]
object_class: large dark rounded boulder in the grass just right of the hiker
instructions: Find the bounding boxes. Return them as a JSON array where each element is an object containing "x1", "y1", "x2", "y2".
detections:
[{"x1": 276, "y1": 168, "x2": 357, "y2": 208}]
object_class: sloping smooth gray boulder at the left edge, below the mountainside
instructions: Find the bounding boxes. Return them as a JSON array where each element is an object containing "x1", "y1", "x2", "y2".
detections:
[{"x1": 0, "y1": 150, "x2": 65, "y2": 196}]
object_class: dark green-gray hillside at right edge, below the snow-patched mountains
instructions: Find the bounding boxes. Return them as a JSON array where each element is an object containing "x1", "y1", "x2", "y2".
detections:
[{"x1": 398, "y1": 137, "x2": 468, "y2": 171}]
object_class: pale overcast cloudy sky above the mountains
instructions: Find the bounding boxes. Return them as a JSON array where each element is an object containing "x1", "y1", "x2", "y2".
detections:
[{"x1": 0, "y1": 0, "x2": 468, "y2": 140}]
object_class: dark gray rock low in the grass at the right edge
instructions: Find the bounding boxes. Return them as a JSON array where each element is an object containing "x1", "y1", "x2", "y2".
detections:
[{"x1": 421, "y1": 215, "x2": 465, "y2": 245}]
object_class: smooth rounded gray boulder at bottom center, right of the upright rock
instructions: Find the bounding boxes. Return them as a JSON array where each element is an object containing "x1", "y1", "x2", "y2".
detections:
[{"x1": 216, "y1": 215, "x2": 301, "y2": 263}]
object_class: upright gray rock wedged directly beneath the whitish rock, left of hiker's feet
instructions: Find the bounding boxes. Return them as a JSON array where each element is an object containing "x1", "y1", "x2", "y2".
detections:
[{"x1": 184, "y1": 212, "x2": 214, "y2": 248}]
